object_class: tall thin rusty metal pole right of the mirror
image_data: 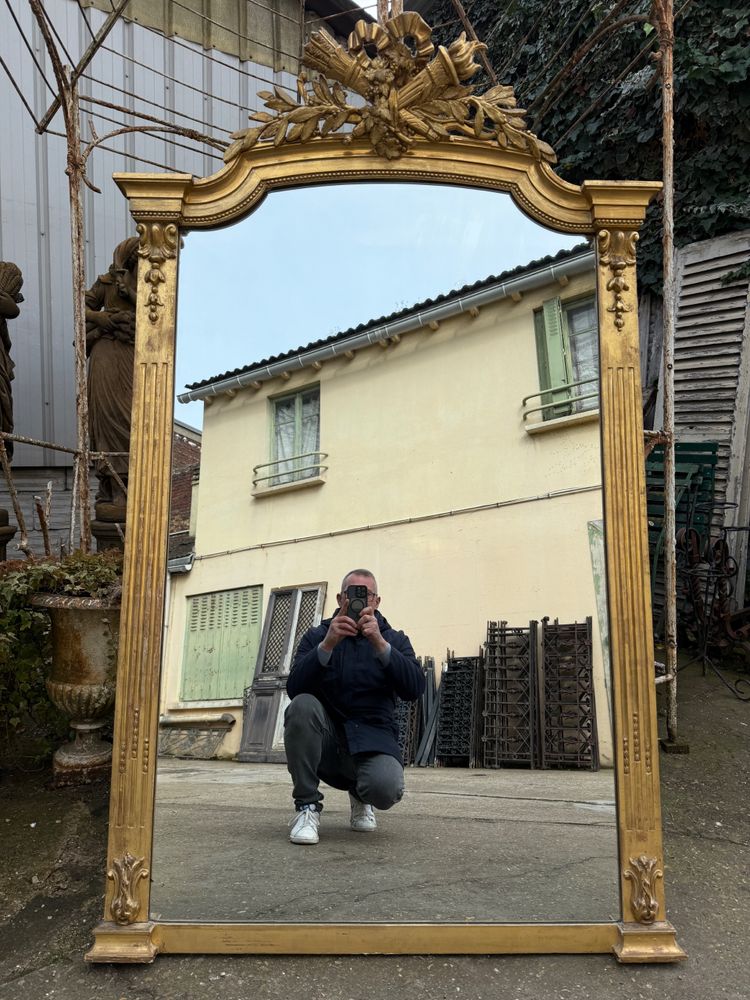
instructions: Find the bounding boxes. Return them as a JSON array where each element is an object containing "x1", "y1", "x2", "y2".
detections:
[{"x1": 652, "y1": 0, "x2": 677, "y2": 749}]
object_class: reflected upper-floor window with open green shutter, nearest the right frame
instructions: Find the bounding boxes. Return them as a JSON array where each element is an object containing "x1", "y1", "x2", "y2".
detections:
[{"x1": 534, "y1": 295, "x2": 599, "y2": 420}]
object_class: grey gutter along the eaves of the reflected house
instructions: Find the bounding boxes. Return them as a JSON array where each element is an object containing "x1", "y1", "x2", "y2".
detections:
[{"x1": 177, "y1": 250, "x2": 595, "y2": 403}]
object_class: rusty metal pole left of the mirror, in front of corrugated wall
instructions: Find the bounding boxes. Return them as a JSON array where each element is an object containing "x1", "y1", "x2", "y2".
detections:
[{"x1": 29, "y1": 0, "x2": 91, "y2": 552}]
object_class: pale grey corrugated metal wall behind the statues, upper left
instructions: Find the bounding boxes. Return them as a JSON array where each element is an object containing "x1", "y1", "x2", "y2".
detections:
[{"x1": 0, "y1": 0, "x2": 299, "y2": 555}]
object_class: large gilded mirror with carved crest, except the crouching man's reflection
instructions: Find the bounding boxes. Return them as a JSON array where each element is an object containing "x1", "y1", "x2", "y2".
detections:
[{"x1": 88, "y1": 5, "x2": 682, "y2": 961}]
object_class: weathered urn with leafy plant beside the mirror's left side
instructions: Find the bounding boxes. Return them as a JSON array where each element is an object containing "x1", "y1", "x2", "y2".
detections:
[{"x1": 0, "y1": 549, "x2": 122, "y2": 784}]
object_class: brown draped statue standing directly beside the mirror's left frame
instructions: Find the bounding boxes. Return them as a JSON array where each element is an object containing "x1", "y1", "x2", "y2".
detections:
[{"x1": 86, "y1": 236, "x2": 138, "y2": 522}]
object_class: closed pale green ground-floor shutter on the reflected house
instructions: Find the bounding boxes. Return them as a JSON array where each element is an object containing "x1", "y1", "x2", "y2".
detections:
[{"x1": 180, "y1": 587, "x2": 263, "y2": 701}]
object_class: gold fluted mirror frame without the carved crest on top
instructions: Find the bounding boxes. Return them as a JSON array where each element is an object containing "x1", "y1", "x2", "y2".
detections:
[{"x1": 87, "y1": 17, "x2": 684, "y2": 962}]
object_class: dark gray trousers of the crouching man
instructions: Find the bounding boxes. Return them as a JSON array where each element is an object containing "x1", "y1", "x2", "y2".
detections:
[{"x1": 284, "y1": 694, "x2": 404, "y2": 809}]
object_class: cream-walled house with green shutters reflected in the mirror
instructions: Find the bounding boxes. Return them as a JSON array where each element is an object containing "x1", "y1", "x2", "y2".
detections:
[{"x1": 160, "y1": 244, "x2": 612, "y2": 766}]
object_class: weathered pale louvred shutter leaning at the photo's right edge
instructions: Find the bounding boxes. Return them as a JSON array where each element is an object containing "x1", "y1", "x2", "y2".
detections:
[{"x1": 657, "y1": 230, "x2": 750, "y2": 584}]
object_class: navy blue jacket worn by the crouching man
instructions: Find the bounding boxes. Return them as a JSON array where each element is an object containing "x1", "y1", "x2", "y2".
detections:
[{"x1": 286, "y1": 611, "x2": 425, "y2": 760}]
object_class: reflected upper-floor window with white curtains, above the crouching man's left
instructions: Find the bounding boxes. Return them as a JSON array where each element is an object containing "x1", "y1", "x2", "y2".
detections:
[{"x1": 270, "y1": 385, "x2": 320, "y2": 486}]
